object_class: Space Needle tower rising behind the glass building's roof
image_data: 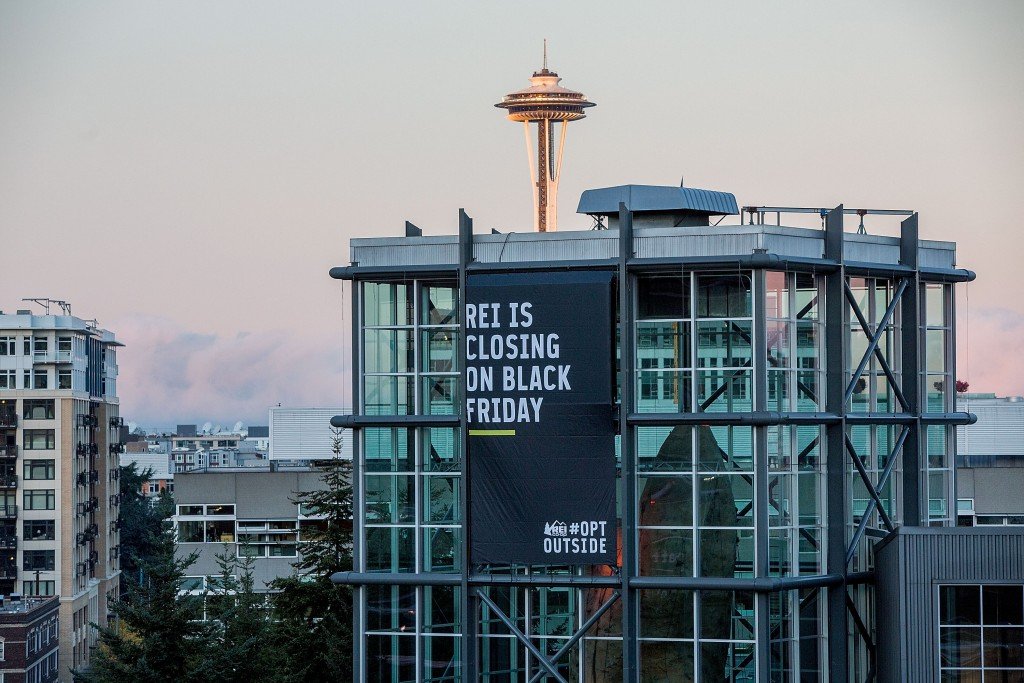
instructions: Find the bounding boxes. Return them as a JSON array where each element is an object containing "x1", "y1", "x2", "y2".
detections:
[{"x1": 495, "y1": 41, "x2": 594, "y2": 232}]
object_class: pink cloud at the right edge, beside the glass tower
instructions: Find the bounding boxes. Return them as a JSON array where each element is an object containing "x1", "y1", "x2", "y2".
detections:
[{"x1": 956, "y1": 308, "x2": 1024, "y2": 396}]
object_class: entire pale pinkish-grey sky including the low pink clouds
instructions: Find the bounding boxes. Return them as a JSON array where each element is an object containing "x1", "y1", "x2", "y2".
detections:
[{"x1": 0, "y1": 0, "x2": 1024, "y2": 425}]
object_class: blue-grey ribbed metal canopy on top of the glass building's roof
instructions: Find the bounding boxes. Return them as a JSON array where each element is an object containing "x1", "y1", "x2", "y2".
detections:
[{"x1": 577, "y1": 185, "x2": 739, "y2": 216}]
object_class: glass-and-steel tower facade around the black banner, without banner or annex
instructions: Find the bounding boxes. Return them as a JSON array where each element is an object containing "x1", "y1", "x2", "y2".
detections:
[{"x1": 332, "y1": 193, "x2": 973, "y2": 683}]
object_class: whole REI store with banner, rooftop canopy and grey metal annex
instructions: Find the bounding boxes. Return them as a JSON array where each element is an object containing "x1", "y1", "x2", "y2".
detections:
[{"x1": 331, "y1": 185, "x2": 1024, "y2": 683}]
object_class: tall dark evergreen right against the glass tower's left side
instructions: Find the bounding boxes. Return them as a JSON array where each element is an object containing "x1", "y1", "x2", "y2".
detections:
[{"x1": 273, "y1": 430, "x2": 352, "y2": 682}]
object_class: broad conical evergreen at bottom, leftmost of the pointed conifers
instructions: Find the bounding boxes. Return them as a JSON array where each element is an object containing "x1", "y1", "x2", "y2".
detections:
[{"x1": 73, "y1": 524, "x2": 211, "y2": 683}]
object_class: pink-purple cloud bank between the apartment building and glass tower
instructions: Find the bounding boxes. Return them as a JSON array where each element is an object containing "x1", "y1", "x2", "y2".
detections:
[{"x1": 109, "y1": 314, "x2": 349, "y2": 426}]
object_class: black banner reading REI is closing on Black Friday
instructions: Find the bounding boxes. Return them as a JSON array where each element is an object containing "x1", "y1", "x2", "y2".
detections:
[{"x1": 464, "y1": 272, "x2": 616, "y2": 564}]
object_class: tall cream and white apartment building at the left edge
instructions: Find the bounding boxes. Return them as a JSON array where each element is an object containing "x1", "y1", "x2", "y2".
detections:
[{"x1": 0, "y1": 310, "x2": 124, "y2": 680}]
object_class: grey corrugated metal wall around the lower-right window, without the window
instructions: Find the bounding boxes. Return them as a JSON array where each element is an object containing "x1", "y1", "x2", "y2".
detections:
[{"x1": 876, "y1": 527, "x2": 1024, "y2": 683}]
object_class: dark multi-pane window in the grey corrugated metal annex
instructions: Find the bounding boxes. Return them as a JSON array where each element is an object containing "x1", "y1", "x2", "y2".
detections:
[{"x1": 939, "y1": 585, "x2": 1024, "y2": 681}]
